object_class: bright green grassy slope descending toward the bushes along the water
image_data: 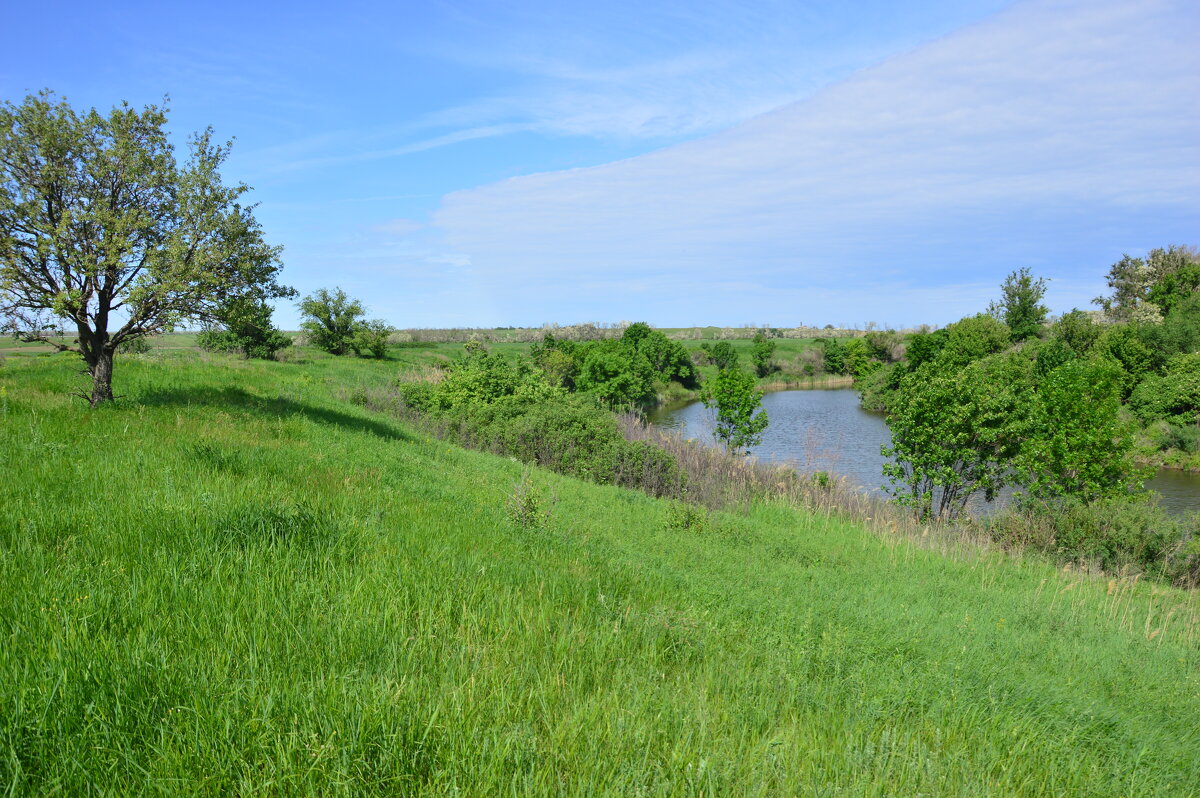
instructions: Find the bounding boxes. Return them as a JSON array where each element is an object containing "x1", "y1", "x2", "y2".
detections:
[{"x1": 0, "y1": 353, "x2": 1200, "y2": 796}]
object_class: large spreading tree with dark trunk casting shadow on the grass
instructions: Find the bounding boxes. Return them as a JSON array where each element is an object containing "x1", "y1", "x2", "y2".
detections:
[{"x1": 0, "y1": 91, "x2": 290, "y2": 407}]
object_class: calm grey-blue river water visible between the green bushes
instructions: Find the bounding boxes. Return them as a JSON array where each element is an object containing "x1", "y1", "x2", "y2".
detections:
[{"x1": 650, "y1": 389, "x2": 1200, "y2": 512}]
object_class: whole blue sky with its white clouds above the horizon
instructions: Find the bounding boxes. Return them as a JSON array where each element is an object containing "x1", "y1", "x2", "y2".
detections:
[{"x1": 0, "y1": 0, "x2": 1200, "y2": 328}]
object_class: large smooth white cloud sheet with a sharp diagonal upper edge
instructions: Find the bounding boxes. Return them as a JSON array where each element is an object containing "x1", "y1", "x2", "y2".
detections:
[{"x1": 434, "y1": 0, "x2": 1200, "y2": 323}]
